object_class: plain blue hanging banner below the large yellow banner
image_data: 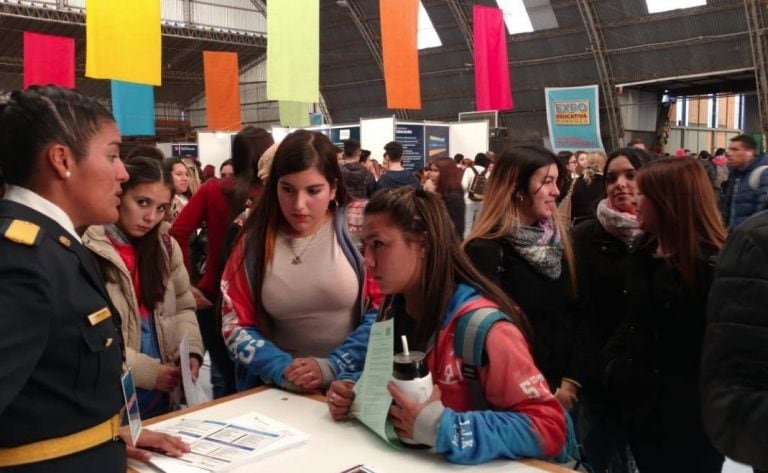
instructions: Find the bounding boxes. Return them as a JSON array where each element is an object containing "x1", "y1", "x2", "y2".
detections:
[{"x1": 112, "y1": 80, "x2": 155, "y2": 136}]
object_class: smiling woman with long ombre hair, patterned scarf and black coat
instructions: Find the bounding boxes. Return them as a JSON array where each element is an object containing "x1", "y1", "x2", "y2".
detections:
[{"x1": 464, "y1": 146, "x2": 580, "y2": 409}]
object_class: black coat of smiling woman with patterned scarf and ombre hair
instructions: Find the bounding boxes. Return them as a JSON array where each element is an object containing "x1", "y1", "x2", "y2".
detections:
[{"x1": 466, "y1": 239, "x2": 579, "y2": 389}]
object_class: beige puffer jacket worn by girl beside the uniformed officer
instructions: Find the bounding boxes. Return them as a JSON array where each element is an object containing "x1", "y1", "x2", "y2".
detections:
[{"x1": 83, "y1": 225, "x2": 205, "y2": 389}]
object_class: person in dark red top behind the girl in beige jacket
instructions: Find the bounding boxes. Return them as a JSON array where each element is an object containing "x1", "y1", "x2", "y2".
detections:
[{"x1": 170, "y1": 126, "x2": 274, "y2": 398}]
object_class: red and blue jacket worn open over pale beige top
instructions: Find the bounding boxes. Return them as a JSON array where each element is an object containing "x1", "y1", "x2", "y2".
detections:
[{"x1": 221, "y1": 208, "x2": 376, "y2": 390}]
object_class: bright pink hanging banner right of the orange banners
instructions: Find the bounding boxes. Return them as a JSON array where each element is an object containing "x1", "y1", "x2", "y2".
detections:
[{"x1": 472, "y1": 5, "x2": 514, "y2": 111}]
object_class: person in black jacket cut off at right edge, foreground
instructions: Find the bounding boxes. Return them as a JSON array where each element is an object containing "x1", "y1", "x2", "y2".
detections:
[{"x1": 701, "y1": 212, "x2": 768, "y2": 472}]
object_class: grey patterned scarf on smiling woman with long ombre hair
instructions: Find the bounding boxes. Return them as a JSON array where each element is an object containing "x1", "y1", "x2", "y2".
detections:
[{"x1": 507, "y1": 219, "x2": 563, "y2": 280}]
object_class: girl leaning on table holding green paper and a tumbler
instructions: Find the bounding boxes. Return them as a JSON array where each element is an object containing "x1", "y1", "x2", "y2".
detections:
[{"x1": 328, "y1": 187, "x2": 566, "y2": 464}]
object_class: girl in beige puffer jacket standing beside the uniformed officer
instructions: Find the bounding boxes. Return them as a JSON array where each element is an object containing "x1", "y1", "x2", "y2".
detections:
[{"x1": 83, "y1": 156, "x2": 205, "y2": 418}]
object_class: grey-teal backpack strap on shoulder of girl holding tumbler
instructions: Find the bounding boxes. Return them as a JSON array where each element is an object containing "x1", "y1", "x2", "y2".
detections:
[{"x1": 453, "y1": 307, "x2": 510, "y2": 410}]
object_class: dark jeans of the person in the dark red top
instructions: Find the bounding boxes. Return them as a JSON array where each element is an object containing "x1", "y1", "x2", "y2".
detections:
[{"x1": 197, "y1": 300, "x2": 236, "y2": 399}]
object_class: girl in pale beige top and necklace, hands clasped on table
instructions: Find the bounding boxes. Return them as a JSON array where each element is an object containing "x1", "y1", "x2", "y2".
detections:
[{"x1": 221, "y1": 130, "x2": 375, "y2": 391}]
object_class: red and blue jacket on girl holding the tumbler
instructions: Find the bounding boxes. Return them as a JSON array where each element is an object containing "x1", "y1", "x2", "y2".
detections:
[{"x1": 378, "y1": 284, "x2": 566, "y2": 464}]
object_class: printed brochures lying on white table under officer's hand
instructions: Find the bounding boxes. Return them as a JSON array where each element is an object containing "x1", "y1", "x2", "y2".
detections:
[{"x1": 131, "y1": 412, "x2": 308, "y2": 473}]
